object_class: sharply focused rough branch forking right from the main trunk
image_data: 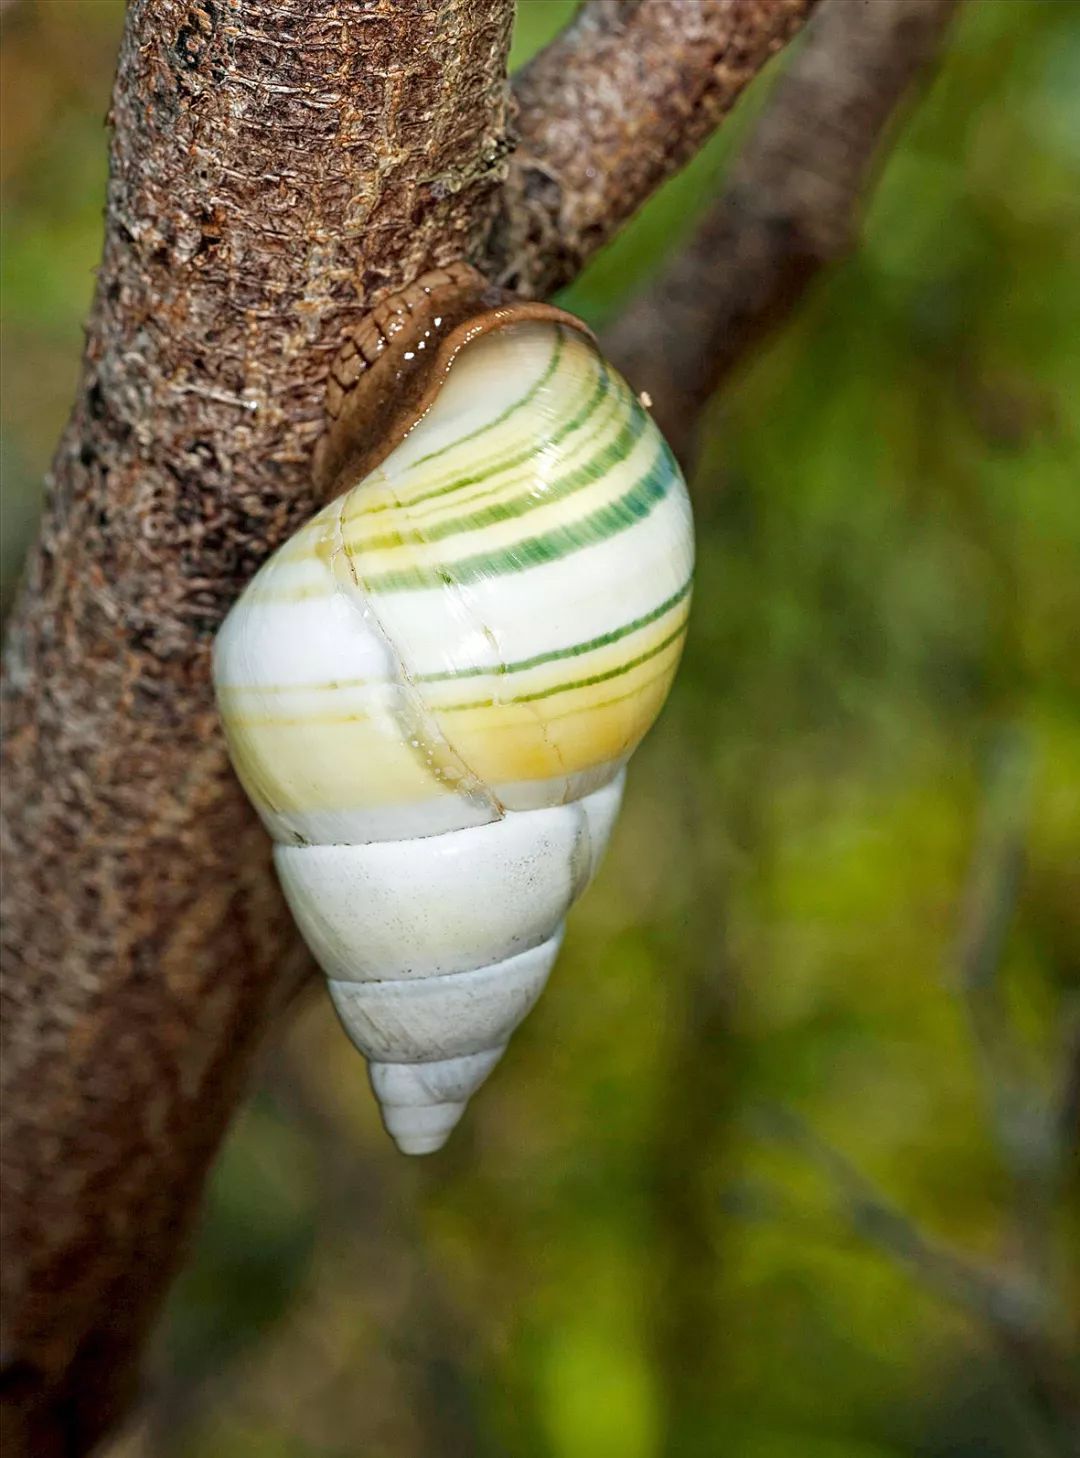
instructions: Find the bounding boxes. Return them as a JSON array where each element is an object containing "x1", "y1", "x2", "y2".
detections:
[{"x1": 488, "y1": 0, "x2": 816, "y2": 296}]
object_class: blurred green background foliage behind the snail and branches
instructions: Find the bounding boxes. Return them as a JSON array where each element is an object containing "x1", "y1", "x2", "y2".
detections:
[{"x1": 3, "y1": 0, "x2": 1080, "y2": 1458}]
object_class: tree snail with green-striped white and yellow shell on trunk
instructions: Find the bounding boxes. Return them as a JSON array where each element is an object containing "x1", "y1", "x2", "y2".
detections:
[{"x1": 214, "y1": 264, "x2": 694, "y2": 1153}]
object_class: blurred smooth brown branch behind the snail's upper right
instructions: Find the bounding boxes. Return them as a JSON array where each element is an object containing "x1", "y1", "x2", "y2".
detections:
[{"x1": 605, "y1": 0, "x2": 959, "y2": 467}]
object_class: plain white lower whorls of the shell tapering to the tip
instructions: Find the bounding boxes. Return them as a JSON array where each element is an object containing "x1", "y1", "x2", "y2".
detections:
[{"x1": 274, "y1": 774, "x2": 624, "y2": 1153}]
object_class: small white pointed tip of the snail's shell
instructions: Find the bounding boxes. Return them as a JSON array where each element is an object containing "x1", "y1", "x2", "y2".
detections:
[{"x1": 369, "y1": 1042, "x2": 506, "y2": 1155}]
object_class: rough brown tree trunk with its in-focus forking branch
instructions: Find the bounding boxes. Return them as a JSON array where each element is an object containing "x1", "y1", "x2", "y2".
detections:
[{"x1": 3, "y1": 0, "x2": 812, "y2": 1458}]
